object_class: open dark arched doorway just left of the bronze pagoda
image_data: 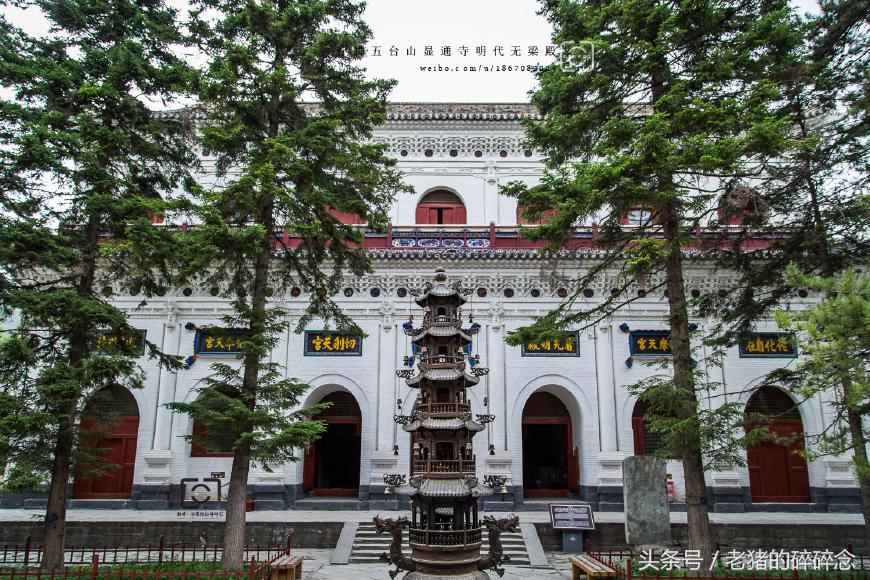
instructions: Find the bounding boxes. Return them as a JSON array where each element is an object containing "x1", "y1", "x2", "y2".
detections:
[{"x1": 302, "y1": 391, "x2": 362, "y2": 497}]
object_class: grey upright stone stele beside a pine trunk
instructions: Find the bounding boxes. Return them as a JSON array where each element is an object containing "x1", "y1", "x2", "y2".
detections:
[{"x1": 622, "y1": 455, "x2": 671, "y2": 546}]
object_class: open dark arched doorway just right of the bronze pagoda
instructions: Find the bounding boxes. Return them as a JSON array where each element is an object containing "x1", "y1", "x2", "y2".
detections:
[{"x1": 523, "y1": 392, "x2": 579, "y2": 497}]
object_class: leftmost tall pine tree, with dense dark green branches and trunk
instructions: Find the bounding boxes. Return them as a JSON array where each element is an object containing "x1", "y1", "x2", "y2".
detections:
[{"x1": 0, "y1": 0, "x2": 190, "y2": 569}]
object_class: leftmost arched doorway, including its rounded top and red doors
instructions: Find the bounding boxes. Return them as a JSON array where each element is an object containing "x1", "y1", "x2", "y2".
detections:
[{"x1": 73, "y1": 385, "x2": 139, "y2": 499}]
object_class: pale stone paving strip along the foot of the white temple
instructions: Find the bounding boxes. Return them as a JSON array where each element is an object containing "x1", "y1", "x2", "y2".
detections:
[{"x1": 0, "y1": 508, "x2": 864, "y2": 525}]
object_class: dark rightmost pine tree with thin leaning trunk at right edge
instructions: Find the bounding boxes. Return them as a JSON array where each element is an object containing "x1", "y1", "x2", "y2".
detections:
[{"x1": 699, "y1": 0, "x2": 870, "y2": 549}]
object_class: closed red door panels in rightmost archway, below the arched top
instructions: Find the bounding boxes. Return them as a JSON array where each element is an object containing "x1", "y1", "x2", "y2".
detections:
[{"x1": 747, "y1": 419, "x2": 810, "y2": 502}]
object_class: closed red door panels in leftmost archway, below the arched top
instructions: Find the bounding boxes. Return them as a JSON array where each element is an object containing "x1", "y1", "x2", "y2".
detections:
[{"x1": 73, "y1": 417, "x2": 139, "y2": 499}]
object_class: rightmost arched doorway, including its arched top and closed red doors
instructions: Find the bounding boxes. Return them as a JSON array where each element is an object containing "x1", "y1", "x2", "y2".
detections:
[{"x1": 746, "y1": 387, "x2": 810, "y2": 502}]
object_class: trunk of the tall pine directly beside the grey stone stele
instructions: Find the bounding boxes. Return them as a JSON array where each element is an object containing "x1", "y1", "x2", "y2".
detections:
[{"x1": 661, "y1": 199, "x2": 711, "y2": 570}]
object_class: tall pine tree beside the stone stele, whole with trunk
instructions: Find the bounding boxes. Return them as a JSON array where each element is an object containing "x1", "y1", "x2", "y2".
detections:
[{"x1": 505, "y1": 0, "x2": 794, "y2": 561}]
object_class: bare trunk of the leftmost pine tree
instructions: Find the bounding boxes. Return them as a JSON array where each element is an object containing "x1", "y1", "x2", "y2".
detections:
[{"x1": 39, "y1": 215, "x2": 100, "y2": 570}]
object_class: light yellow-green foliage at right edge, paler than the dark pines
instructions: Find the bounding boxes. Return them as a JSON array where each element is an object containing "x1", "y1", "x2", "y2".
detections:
[{"x1": 768, "y1": 264, "x2": 870, "y2": 481}]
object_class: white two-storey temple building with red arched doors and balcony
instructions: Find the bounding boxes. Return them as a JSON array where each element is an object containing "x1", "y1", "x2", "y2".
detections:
[{"x1": 3, "y1": 103, "x2": 860, "y2": 512}]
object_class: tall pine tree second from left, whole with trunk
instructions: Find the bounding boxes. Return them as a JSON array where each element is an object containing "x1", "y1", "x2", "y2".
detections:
[{"x1": 176, "y1": 0, "x2": 403, "y2": 571}]
